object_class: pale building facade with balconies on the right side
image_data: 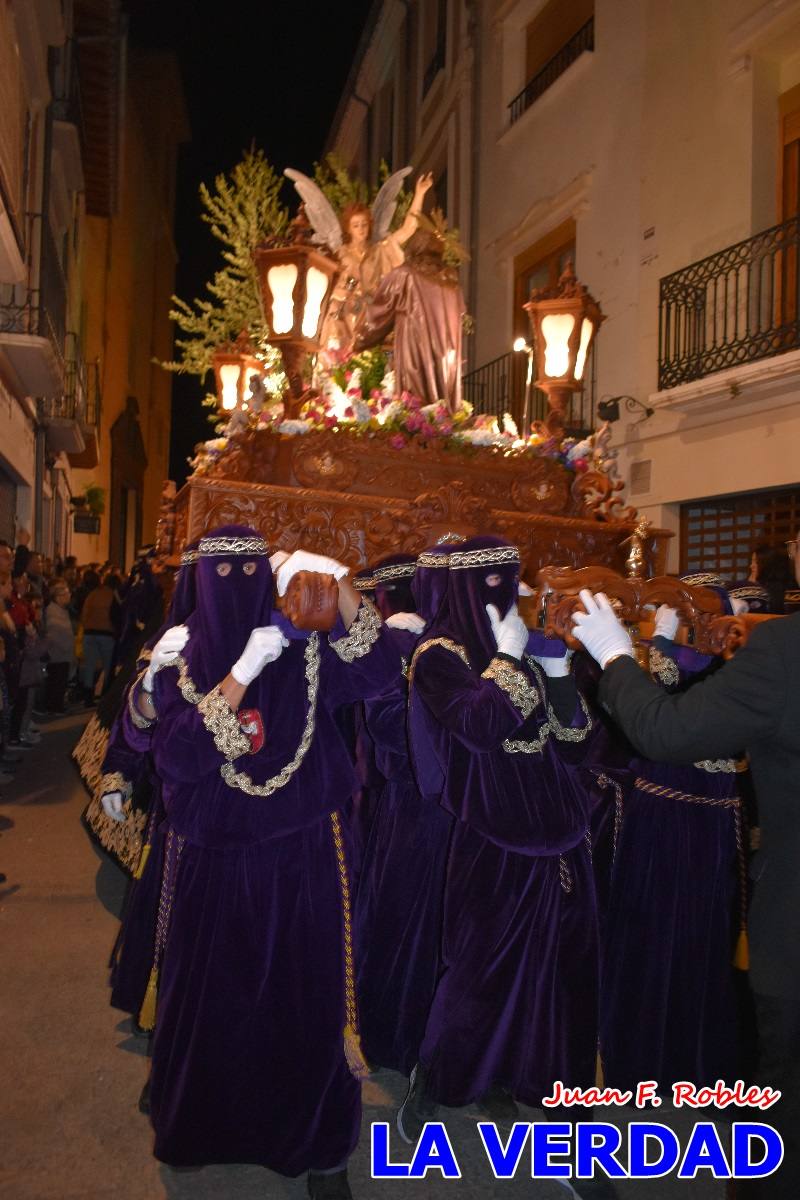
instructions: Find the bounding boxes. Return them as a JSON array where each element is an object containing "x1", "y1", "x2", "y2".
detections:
[{"x1": 329, "y1": 0, "x2": 800, "y2": 578}]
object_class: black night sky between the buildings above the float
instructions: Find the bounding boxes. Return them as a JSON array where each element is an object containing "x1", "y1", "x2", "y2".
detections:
[{"x1": 128, "y1": 0, "x2": 372, "y2": 485}]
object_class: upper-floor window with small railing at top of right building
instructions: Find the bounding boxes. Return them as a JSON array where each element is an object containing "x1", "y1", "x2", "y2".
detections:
[{"x1": 509, "y1": 0, "x2": 595, "y2": 125}]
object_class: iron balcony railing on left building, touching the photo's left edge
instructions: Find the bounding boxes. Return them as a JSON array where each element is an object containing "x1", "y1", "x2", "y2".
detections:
[{"x1": 0, "y1": 214, "x2": 67, "y2": 361}]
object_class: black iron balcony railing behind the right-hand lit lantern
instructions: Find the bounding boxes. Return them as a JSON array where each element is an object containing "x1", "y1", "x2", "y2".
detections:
[{"x1": 462, "y1": 349, "x2": 597, "y2": 434}]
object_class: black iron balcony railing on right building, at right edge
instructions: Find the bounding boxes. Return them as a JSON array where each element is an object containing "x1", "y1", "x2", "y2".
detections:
[{"x1": 658, "y1": 217, "x2": 800, "y2": 389}]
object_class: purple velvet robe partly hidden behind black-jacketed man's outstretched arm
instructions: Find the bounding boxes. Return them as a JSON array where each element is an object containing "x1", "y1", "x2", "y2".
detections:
[{"x1": 601, "y1": 637, "x2": 738, "y2": 1090}]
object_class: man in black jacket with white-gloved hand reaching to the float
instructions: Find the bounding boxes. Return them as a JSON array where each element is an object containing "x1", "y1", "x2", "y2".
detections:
[{"x1": 575, "y1": 592, "x2": 800, "y2": 1200}]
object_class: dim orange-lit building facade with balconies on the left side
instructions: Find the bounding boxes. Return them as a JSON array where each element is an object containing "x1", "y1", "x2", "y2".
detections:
[{"x1": 0, "y1": 0, "x2": 188, "y2": 566}]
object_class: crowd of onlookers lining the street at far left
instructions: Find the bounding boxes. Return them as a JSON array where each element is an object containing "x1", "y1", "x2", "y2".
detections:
[{"x1": 0, "y1": 532, "x2": 130, "y2": 785}]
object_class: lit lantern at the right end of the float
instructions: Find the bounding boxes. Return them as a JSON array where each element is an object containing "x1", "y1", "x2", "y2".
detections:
[{"x1": 523, "y1": 262, "x2": 606, "y2": 434}]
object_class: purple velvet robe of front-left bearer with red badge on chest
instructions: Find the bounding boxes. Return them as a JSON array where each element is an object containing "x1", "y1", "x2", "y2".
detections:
[{"x1": 135, "y1": 604, "x2": 399, "y2": 1175}]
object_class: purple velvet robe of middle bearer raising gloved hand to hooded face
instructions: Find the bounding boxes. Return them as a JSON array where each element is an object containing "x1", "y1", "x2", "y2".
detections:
[{"x1": 410, "y1": 638, "x2": 597, "y2": 1105}]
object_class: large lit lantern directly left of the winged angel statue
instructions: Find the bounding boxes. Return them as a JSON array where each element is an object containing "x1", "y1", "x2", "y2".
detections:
[{"x1": 253, "y1": 221, "x2": 339, "y2": 416}]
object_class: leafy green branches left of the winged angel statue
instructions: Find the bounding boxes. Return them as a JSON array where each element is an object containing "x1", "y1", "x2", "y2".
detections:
[{"x1": 161, "y1": 149, "x2": 289, "y2": 378}]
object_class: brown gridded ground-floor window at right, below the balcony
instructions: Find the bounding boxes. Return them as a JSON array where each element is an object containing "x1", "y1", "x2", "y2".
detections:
[{"x1": 680, "y1": 488, "x2": 800, "y2": 583}]
